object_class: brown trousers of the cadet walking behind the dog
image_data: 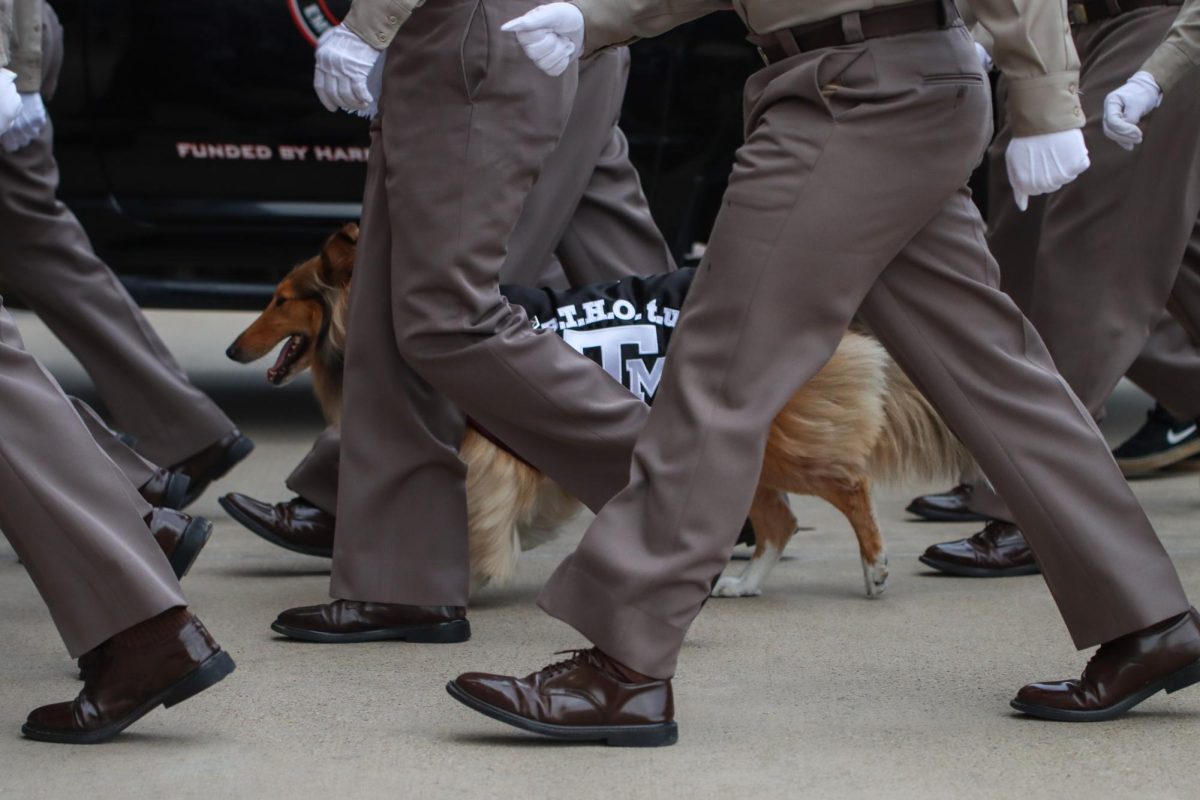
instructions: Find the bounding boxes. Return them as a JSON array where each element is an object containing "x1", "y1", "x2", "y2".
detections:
[{"x1": 286, "y1": 48, "x2": 674, "y2": 513}]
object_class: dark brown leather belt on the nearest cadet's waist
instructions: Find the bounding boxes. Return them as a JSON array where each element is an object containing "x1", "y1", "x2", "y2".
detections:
[{"x1": 749, "y1": 0, "x2": 959, "y2": 64}]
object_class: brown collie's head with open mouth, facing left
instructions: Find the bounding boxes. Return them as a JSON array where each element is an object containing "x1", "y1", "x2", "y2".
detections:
[{"x1": 226, "y1": 223, "x2": 359, "y2": 386}]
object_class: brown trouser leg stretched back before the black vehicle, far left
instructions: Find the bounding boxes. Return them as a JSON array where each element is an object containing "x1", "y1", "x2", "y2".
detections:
[{"x1": 0, "y1": 6, "x2": 234, "y2": 464}]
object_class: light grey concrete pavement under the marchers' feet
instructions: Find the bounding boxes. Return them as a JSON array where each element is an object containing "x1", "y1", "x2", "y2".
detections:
[{"x1": 0, "y1": 313, "x2": 1200, "y2": 800}]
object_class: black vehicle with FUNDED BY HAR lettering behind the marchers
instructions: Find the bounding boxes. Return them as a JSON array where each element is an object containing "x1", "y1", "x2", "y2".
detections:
[{"x1": 52, "y1": 0, "x2": 761, "y2": 308}]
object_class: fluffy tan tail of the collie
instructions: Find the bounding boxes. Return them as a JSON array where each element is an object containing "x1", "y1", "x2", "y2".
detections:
[{"x1": 869, "y1": 357, "x2": 974, "y2": 481}]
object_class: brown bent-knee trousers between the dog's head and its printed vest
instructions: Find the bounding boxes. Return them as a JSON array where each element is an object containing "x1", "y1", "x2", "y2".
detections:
[{"x1": 330, "y1": 0, "x2": 676, "y2": 606}]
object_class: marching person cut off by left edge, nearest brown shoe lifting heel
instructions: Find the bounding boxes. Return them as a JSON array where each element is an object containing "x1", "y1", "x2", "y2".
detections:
[{"x1": 0, "y1": 0, "x2": 234, "y2": 744}]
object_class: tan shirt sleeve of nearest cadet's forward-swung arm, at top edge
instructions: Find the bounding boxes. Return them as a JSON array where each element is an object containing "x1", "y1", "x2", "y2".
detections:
[{"x1": 571, "y1": 0, "x2": 733, "y2": 55}]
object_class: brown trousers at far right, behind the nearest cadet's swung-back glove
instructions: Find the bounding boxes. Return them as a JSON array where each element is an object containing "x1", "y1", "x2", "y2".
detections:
[{"x1": 971, "y1": 6, "x2": 1200, "y2": 519}]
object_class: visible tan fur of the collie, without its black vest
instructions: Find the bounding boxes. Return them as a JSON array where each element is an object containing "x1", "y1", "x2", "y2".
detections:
[{"x1": 229, "y1": 225, "x2": 971, "y2": 597}]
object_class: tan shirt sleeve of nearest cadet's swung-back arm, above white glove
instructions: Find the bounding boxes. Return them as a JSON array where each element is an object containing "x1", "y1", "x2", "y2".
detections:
[{"x1": 970, "y1": 0, "x2": 1084, "y2": 137}]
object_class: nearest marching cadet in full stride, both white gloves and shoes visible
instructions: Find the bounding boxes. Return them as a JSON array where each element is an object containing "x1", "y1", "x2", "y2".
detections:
[{"x1": 448, "y1": 0, "x2": 1200, "y2": 746}]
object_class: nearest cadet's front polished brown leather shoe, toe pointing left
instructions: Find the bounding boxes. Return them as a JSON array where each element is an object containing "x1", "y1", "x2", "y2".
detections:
[{"x1": 446, "y1": 648, "x2": 679, "y2": 747}]
